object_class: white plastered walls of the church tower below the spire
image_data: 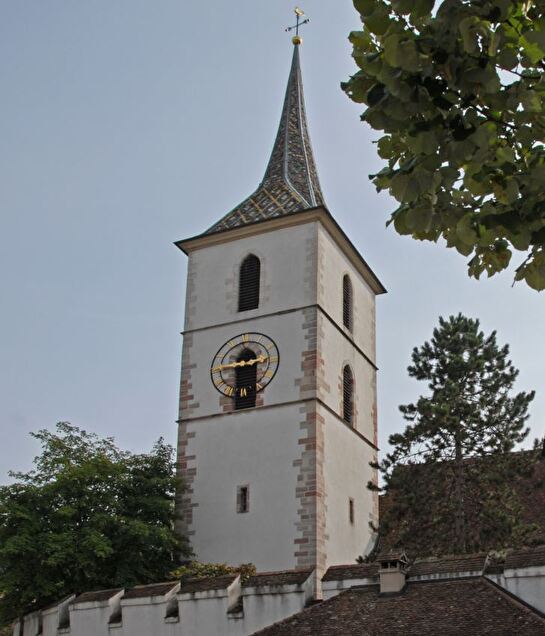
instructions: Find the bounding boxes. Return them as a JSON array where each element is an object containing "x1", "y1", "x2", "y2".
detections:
[{"x1": 179, "y1": 216, "x2": 376, "y2": 572}]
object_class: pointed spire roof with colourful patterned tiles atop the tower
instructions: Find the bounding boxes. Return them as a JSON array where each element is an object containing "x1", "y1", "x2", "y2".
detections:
[{"x1": 206, "y1": 45, "x2": 324, "y2": 234}]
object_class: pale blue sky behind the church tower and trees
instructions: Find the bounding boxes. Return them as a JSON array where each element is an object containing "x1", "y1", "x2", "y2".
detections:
[{"x1": 0, "y1": 0, "x2": 545, "y2": 481}]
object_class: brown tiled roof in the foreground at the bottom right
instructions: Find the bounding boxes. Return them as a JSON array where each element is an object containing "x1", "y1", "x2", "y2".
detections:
[{"x1": 253, "y1": 577, "x2": 545, "y2": 636}]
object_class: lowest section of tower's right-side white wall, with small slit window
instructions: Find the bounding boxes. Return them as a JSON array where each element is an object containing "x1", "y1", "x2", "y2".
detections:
[{"x1": 319, "y1": 408, "x2": 376, "y2": 566}]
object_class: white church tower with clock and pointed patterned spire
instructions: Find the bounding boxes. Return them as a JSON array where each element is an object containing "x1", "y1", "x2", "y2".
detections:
[{"x1": 173, "y1": 37, "x2": 385, "y2": 572}]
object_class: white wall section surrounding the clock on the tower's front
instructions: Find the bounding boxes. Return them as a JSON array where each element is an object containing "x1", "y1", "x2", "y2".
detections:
[{"x1": 182, "y1": 311, "x2": 314, "y2": 418}]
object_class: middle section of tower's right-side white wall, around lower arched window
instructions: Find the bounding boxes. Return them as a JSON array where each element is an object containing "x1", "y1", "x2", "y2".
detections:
[{"x1": 319, "y1": 317, "x2": 376, "y2": 443}]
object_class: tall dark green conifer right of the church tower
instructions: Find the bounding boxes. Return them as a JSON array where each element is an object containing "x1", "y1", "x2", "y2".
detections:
[{"x1": 374, "y1": 314, "x2": 535, "y2": 553}]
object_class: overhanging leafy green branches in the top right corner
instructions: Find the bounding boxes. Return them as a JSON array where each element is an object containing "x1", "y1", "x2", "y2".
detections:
[{"x1": 343, "y1": 0, "x2": 545, "y2": 290}]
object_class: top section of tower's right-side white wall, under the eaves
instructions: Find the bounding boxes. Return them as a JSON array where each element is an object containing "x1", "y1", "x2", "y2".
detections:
[{"x1": 318, "y1": 225, "x2": 376, "y2": 362}]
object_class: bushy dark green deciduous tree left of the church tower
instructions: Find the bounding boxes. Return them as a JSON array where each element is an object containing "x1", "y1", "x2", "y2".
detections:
[{"x1": 0, "y1": 422, "x2": 188, "y2": 620}]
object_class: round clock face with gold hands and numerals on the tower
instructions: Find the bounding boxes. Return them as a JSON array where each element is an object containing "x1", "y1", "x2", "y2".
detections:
[{"x1": 210, "y1": 333, "x2": 280, "y2": 398}]
